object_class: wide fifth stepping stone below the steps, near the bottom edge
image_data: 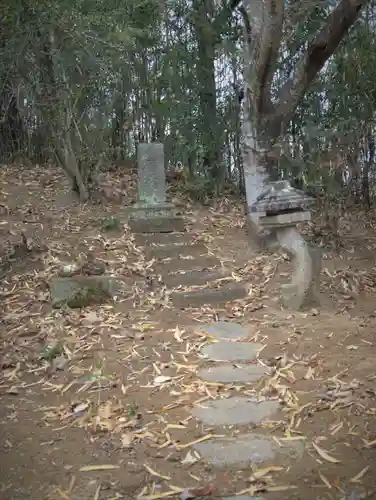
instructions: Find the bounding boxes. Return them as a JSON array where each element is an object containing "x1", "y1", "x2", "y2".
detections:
[{"x1": 193, "y1": 433, "x2": 304, "y2": 468}]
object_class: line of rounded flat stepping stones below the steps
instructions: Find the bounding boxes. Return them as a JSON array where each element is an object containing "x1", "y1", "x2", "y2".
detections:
[{"x1": 192, "y1": 321, "x2": 304, "y2": 474}]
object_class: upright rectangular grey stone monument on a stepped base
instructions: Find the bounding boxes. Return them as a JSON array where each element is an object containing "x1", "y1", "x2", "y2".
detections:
[{"x1": 129, "y1": 142, "x2": 183, "y2": 232}]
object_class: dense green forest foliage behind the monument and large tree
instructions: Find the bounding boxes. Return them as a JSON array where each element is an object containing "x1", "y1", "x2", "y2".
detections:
[{"x1": 0, "y1": 0, "x2": 376, "y2": 205}]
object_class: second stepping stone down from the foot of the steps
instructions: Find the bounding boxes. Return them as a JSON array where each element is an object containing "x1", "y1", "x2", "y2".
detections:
[{"x1": 201, "y1": 340, "x2": 263, "y2": 361}]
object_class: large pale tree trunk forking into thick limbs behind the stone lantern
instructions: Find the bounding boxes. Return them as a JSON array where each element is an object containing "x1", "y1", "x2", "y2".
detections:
[{"x1": 242, "y1": 0, "x2": 369, "y2": 224}]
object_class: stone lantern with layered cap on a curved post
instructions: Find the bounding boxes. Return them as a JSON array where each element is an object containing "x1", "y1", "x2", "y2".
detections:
[{"x1": 250, "y1": 181, "x2": 321, "y2": 309}]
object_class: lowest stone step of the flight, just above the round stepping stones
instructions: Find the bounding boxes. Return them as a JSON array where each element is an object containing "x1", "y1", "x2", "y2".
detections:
[{"x1": 170, "y1": 285, "x2": 247, "y2": 308}]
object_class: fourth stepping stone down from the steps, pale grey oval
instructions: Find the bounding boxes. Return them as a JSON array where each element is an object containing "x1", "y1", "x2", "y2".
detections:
[{"x1": 192, "y1": 397, "x2": 279, "y2": 425}]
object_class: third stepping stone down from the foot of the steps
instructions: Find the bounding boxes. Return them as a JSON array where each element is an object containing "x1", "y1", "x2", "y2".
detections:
[{"x1": 198, "y1": 364, "x2": 267, "y2": 384}]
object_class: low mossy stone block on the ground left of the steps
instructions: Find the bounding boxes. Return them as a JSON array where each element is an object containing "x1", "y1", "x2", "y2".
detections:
[{"x1": 50, "y1": 276, "x2": 133, "y2": 308}]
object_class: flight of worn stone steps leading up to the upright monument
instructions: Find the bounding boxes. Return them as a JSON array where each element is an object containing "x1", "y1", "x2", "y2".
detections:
[{"x1": 131, "y1": 217, "x2": 247, "y2": 309}]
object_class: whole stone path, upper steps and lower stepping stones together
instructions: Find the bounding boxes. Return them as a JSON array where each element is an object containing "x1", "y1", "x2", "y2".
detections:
[{"x1": 132, "y1": 218, "x2": 304, "y2": 500}]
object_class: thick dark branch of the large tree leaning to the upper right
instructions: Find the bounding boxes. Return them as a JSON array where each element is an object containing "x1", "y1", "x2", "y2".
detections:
[{"x1": 276, "y1": 0, "x2": 370, "y2": 123}]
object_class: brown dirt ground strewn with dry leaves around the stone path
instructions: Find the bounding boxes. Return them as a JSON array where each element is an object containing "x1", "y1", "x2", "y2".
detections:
[{"x1": 0, "y1": 166, "x2": 376, "y2": 500}]
